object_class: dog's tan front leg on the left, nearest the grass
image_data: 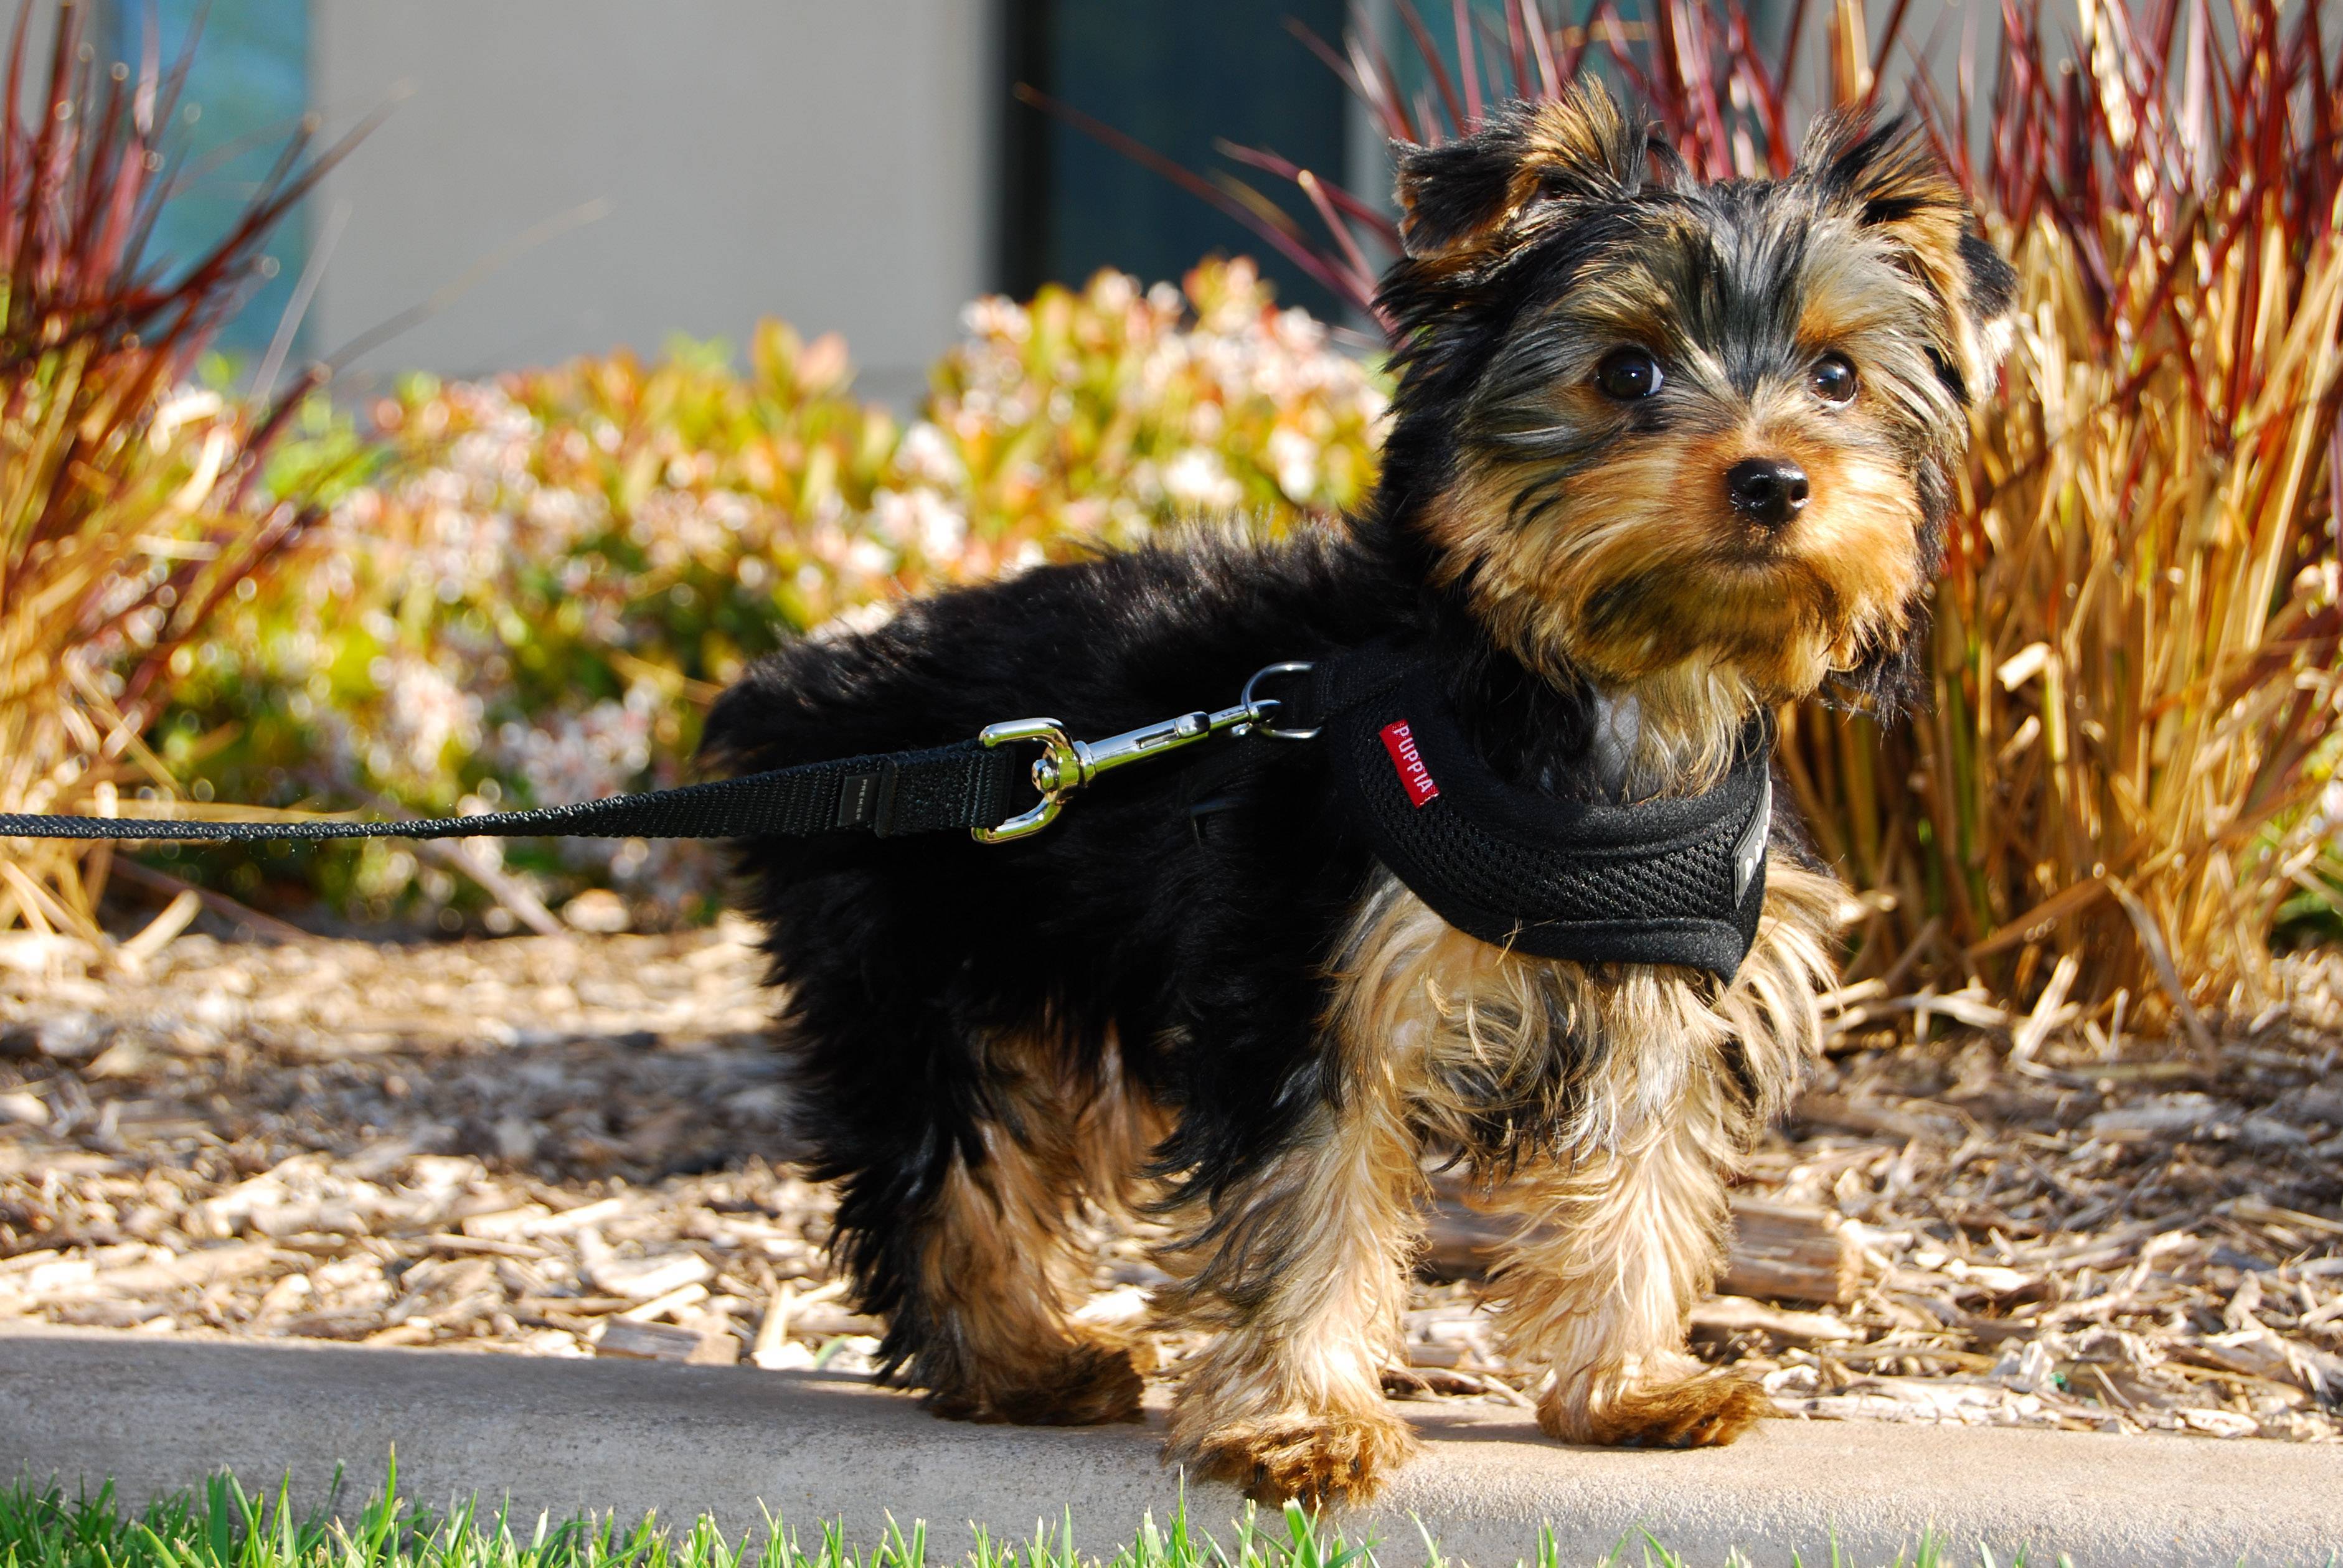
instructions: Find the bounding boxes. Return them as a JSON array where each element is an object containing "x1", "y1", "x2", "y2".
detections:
[{"x1": 1164, "y1": 1087, "x2": 1422, "y2": 1505}]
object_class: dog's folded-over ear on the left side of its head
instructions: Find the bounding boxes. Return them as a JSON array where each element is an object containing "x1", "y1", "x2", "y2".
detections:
[{"x1": 1397, "y1": 82, "x2": 1649, "y2": 265}]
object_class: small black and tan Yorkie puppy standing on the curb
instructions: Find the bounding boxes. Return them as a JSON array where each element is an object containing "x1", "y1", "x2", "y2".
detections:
[{"x1": 707, "y1": 87, "x2": 2015, "y2": 1503}]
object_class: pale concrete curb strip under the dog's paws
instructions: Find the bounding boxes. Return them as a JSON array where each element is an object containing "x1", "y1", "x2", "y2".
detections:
[{"x1": 0, "y1": 1329, "x2": 2343, "y2": 1568}]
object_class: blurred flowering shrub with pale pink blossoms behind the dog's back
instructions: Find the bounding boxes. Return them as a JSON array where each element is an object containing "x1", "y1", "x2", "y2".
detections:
[{"x1": 162, "y1": 260, "x2": 1382, "y2": 928}]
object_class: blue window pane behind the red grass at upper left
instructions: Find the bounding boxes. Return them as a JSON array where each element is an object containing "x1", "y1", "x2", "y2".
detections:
[{"x1": 101, "y1": 0, "x2": 309, "y2": 368}]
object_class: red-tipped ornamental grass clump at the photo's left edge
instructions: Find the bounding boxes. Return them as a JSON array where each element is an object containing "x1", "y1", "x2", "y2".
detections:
[{"x1": 0, "y1": 5, "x2": 351, "y2": 949}]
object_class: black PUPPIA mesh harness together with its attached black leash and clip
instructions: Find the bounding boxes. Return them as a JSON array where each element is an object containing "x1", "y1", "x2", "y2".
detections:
[{"x1": 0, "y1": 647, "x2": 1774, "y2": 980}]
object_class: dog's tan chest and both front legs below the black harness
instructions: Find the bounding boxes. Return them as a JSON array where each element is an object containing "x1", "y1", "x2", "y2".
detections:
[{"x1": 1162, "y1": 860, "x2": 1837, "y2": 1500}]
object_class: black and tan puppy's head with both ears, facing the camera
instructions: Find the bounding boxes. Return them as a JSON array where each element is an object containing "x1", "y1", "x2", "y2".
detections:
[{"x1": 1380, "y1": 87, "x2": 2015, "y2": 698}]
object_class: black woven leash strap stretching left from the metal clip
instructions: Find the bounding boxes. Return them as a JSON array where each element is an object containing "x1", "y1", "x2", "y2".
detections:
[{"x1": 0, "y1": 741, "x2": 1019, "y2": 844}]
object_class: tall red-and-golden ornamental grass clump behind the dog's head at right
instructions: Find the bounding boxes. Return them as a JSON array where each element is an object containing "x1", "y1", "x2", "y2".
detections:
[{"x1": 1190, "y1": 0, "x2": 2343, "y2": 1041}]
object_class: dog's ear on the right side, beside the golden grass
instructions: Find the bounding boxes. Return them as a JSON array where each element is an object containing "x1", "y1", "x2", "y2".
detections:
[{"x1": 1799, "y1": 115, "x2": 2017, "y2": 405}]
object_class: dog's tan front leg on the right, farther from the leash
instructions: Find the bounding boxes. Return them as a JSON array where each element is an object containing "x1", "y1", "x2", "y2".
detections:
[{"x1": 1490, "y1": 1064, "x2": 1769, "y2": 1448}]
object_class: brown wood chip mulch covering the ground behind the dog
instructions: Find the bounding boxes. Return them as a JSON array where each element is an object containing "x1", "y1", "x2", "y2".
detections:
[{"x1": 0, "y1": 924, "x2": 2343, "y2": 1442}]
